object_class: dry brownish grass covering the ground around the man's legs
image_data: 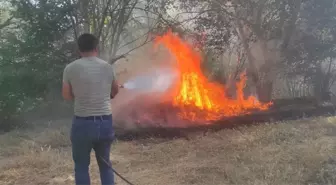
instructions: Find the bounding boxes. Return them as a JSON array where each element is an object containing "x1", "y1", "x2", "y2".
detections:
[{"x1": 0, "y1": 117, "x2": 336, "y2": 185}]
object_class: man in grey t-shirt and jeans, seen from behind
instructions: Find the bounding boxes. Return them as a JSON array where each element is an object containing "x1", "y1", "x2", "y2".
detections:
[{"x1": 62, "y1": 34, "x2": 118, "y2": 185}]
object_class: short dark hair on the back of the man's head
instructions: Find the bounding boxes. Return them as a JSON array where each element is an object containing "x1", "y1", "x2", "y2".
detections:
[{"x1": 77, "y1": 33, "x2": 99, "y2": 52}]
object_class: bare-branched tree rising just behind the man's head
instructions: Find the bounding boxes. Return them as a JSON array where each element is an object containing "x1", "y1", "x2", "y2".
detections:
[{"x1": 62, "y1": 0, "x2": 167, "y2": 63}]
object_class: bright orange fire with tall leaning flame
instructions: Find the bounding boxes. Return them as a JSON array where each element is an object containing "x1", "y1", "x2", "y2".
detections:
[{"x1": 156, "y1": 31, "x2": 272, "y2": 121}]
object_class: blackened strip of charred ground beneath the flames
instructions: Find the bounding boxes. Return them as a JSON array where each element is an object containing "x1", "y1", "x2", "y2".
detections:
[{"x1": 116, "y1": 97, "x2": 335, "y2": 140}]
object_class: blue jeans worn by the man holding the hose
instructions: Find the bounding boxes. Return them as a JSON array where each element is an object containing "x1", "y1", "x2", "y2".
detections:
[{"x1": 71, "y1": 115, "x2": 114, "y2": 185}]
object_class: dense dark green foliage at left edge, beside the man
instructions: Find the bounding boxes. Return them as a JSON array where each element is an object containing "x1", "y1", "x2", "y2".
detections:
[{"x1": 0, "y1": 0, "x2": 73, "y2": 129}]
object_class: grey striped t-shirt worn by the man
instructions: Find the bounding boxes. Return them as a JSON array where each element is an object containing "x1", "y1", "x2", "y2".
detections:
[{"x1": 63, "y1": 57, "x2": 114, "y2": 117}]
